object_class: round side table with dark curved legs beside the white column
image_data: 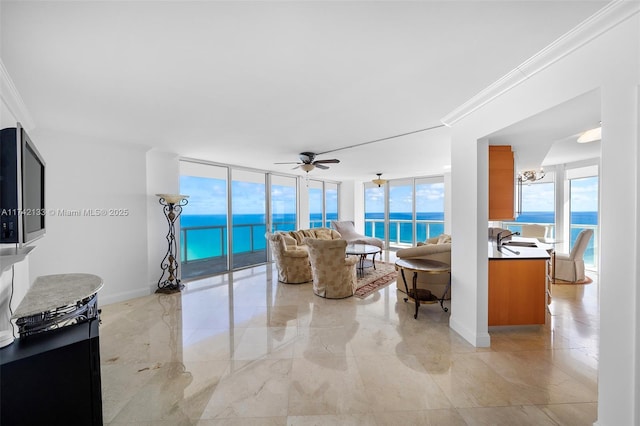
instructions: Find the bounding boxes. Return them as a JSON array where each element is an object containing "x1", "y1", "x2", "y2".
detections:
[{"x1": 396, "y1": 259, "x2": 451, "y2": 318}]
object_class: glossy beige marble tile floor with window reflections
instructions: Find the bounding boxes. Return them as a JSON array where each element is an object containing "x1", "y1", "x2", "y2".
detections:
[{"x1": 100, "y1": 255, "x2": 599, "y2": 426}]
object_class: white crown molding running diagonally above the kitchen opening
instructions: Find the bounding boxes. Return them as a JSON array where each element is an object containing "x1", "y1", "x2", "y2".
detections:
[{"x1": 440, "y1": 0, "x2": 640, "y2": 127}]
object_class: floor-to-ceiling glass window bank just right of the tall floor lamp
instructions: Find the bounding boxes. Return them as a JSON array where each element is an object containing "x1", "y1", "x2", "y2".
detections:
[{"x1": 180, "y1": 160, "x2": 306, "y2": 279}]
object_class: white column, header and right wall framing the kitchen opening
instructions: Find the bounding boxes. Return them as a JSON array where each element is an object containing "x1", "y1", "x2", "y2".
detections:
[{"x1": 451, "y1": 7, "x2": 640, "y2": 426}]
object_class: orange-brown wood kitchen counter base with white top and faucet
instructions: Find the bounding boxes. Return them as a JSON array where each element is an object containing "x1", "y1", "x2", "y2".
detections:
[{"x1": 488, "y1": 237, "x2": 551, "y2": 326}]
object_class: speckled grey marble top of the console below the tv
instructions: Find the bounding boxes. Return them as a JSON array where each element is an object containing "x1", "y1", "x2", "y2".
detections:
[{"x1": 11, "y1": 274, "x2": 102, "y2": 319}]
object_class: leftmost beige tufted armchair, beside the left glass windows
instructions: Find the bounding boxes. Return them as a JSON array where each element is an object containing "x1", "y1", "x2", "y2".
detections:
[{"x1": 267, "y1": 233, "x2": 311, "y2": 284}]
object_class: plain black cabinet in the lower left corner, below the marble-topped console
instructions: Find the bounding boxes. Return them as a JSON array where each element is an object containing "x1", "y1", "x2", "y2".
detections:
[{"x1": 0, "y1": 318, "x2": 102, "y2": 426}]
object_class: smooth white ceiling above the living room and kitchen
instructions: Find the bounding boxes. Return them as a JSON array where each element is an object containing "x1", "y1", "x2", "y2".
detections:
[{"x1": 0, "y1": 0, "x2": 605, "y2": 180}]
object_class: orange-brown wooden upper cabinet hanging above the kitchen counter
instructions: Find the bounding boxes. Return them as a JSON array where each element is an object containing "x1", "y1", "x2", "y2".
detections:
[{"x1": 489, "y1": 145, "x2": 515, "y2": 220}]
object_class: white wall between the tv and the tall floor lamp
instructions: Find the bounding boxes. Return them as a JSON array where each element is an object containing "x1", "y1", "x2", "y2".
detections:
[{"x1": 30, "y1": 129, "x2": 149, "y2": 304}]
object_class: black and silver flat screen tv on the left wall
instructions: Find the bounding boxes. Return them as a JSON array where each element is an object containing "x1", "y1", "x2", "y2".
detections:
[{"x1": 0, "y1": 123, "x2": 46, "y2": 245}]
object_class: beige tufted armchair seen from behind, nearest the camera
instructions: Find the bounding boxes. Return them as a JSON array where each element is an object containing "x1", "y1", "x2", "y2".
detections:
[{"x1": 304, "y1": 238, "x2": 358, "y2": 299}]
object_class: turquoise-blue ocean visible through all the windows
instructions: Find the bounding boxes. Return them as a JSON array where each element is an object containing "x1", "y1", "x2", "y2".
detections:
[{"x1": 180, "y1": 212, "x2": 598, "y2": 263}]
